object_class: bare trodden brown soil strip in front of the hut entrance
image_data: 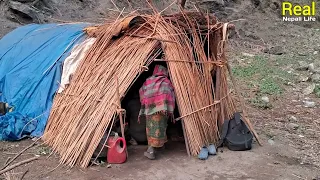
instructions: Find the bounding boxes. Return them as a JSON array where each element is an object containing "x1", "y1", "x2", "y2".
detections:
[{"x1": 0, "y1": 138, "x2": 319, "y2": 180}]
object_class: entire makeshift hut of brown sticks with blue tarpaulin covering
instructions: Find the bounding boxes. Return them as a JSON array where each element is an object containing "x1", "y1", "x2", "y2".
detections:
[{"x1": 0, "y1": 5, "x2": 259, "y2": 167}]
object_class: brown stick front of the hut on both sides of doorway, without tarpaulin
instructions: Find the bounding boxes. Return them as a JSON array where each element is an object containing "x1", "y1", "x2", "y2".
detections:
[{"x1": 44, "y1": 9, "x2": 258, "y2": 167}]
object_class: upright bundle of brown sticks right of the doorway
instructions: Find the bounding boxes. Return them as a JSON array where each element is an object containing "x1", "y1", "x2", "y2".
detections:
[{"x1": 151, "y1": 13, "x2": 235, "y2": 155}]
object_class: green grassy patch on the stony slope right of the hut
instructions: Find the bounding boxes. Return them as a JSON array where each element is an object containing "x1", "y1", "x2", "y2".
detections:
[{"x1": 233, "y1": 55, "x2": 295, "y2": 108}]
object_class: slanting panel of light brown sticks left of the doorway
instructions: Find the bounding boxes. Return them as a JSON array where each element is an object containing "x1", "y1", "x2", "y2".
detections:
[{"x1": 44, "y1": 17, "x2": 160, "y2": 167}]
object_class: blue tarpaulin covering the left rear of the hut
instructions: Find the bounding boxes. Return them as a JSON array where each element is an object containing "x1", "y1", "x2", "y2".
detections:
[{"x1": 0, "y1": 24, "x2": 88, "y2": 141}]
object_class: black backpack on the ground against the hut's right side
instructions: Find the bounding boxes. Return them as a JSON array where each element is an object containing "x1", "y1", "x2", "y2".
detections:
[{"x1": 218, "y1": 112, "x2": 253, "y2": 151}]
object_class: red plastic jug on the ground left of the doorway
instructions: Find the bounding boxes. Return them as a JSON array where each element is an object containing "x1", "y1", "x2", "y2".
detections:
[{"x1": 107, "y1": 137, "x2": 127, "y2": 164}]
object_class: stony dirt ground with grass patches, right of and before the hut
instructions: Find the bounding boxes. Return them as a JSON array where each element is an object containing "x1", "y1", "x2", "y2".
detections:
[{"x1": 0, "y1": 1, "x2": 320, "y2": 180}]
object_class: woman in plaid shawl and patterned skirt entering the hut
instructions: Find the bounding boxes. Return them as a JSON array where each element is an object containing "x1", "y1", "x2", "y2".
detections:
[{"x1": 139, "y1": 65, "x2": 175, "y2": 159}]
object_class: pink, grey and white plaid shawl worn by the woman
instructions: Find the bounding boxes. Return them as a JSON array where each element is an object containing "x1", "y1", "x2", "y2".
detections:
[{"x1": 139, "y1": 65, "x2": 175, "y2": 118}]
